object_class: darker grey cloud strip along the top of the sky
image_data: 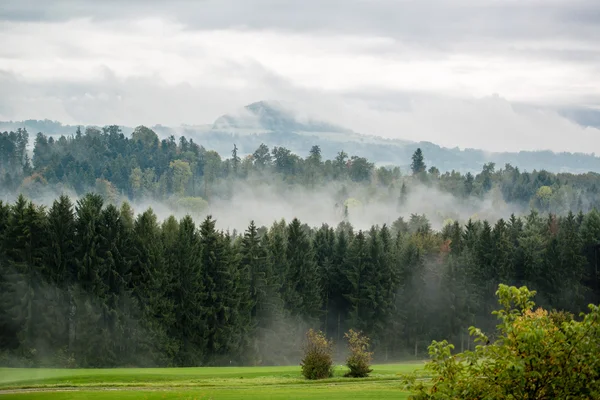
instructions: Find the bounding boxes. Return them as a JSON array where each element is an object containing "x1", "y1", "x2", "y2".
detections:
[{"x1": 0, "y1": 0, "x2": 600, "y2": 42}]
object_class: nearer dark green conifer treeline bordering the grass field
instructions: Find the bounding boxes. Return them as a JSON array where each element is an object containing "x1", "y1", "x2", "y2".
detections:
[{"x1": 0, "y1": 194, "x2": 600, "y2": 367}]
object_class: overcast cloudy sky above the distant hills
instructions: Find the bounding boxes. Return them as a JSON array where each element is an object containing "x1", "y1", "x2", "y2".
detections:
[{"x1": 0, "y1": 0, "x2": 600, "y2": 154}]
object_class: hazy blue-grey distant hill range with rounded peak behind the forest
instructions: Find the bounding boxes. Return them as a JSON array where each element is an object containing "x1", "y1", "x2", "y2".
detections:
[{"x1": 0, "y1": 101, "x2": 600, "y2": 173}]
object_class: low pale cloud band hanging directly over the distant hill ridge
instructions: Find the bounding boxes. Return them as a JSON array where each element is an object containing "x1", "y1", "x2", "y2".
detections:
[{"x1": 0, "y1": 66, "x2": 600, "y2": 153}]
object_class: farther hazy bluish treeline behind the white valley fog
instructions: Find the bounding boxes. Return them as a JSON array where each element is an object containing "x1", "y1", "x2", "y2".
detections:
[{"x1": 0, "y1": 126, "x2": 600, "y2": 215}]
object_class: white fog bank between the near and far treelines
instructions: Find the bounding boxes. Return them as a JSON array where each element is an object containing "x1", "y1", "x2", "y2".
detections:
[{"x1": 125, "y1": 181, "x2": 527, "y2": 231}]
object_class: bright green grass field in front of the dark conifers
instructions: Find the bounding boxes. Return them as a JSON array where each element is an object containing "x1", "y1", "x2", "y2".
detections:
[{"x1": 0, "y1": 363, "x2": 423, "y2": 400}]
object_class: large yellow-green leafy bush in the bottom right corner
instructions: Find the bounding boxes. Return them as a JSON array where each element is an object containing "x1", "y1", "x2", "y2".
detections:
[{"x1": 413, "y1": 285, "x2": 600, "y2": 400}]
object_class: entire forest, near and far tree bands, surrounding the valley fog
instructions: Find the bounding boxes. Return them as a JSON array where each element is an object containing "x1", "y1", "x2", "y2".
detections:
[{"x1": 0, "y1": 127, "x2": 600, "y2": 367}]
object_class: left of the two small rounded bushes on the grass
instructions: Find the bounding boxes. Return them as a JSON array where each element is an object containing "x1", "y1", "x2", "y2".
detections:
[{"x1": 300, "y1": 329, "x2": 333, "y2": 379}]
